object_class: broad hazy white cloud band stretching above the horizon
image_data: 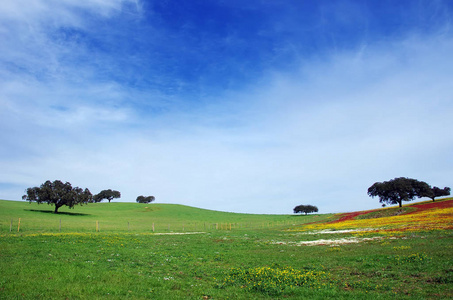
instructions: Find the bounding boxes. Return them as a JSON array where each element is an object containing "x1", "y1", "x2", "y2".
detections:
[{"x1": 0, "y1": 1, "x2": 453, "y2": 213}]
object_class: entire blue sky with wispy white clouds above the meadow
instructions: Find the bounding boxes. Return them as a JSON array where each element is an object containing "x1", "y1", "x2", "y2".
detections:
[{"x1": 0, "y1": 0, "x2": 453, "y2": 213}]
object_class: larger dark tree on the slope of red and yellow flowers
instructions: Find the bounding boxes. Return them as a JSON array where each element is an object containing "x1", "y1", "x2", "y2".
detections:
[{"x1": 368, "y1": 177, "x2": 431, "y2": 207}]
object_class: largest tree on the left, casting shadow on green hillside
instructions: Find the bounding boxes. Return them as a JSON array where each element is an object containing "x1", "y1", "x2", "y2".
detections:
[{"x1": 22, "y1": 180, "x2": 93, "y2": 214}]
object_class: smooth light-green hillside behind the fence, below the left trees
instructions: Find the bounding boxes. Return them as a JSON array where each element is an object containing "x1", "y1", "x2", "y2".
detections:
[{"x1": 0, "y1": 200, "x2": 322, "y2": 234}]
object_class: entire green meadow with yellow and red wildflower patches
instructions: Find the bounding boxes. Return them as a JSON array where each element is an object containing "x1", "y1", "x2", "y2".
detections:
[{"x1": 0, "y1": 198, "x2": 453, "y2": 299}]
